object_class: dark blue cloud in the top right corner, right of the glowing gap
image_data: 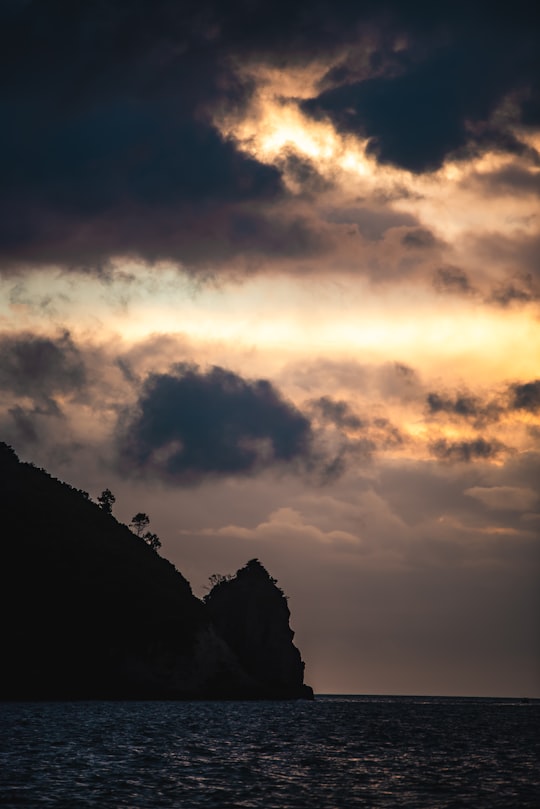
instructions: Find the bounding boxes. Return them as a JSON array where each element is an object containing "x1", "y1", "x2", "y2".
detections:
[{"x1": 304, "y1": 3, "x2": 539, "y2": 172}]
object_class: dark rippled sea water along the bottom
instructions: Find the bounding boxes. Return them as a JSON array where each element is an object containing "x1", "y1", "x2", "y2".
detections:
[{"x1": 0, "y1": 696, "x2": 540, "y2": 809}]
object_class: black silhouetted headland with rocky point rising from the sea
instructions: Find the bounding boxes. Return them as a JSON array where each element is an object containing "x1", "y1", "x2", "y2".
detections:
[{"x1": 0, "y1": 443, "x2": 313, "y2": 699}]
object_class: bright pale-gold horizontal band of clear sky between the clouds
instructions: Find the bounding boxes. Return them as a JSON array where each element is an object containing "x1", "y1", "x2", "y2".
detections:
[{"x1": 3, "y1": 269, "x2": 540, "y2": 388}]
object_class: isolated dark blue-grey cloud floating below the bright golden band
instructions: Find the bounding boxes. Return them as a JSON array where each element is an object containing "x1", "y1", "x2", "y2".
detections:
[{"x1": 119, "y1": 364, "x2": 311, "y2": 483}]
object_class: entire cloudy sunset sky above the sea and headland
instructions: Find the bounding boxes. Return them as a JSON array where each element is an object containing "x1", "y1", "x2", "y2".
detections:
[{"x1": 0, "y1": 0, "x2": 540, "y2": 697}]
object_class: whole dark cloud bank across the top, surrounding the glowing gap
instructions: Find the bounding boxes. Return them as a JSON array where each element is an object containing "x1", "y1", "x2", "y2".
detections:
[{"x1": 0, "y1": 0, "x2": 538, "y2": 272}]
